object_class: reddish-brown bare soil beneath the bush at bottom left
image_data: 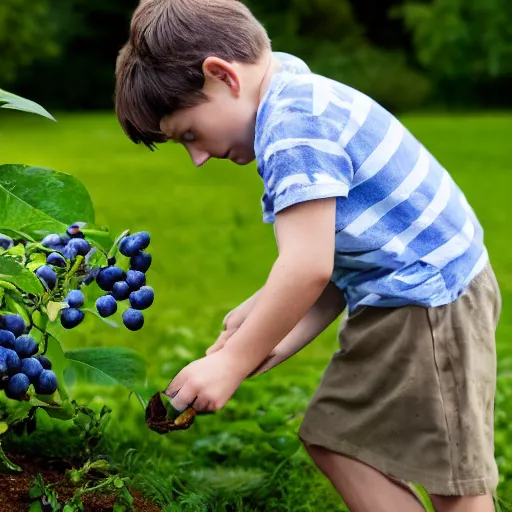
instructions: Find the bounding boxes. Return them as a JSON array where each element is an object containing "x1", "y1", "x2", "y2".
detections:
[{"x1": 0, "y1": 454, "x2": 161, "y2": 512}]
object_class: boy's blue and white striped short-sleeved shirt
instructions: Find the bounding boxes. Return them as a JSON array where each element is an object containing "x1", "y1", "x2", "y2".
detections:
[{"x1": 255, "y1": 53, "x2": 488, "y2": 312}]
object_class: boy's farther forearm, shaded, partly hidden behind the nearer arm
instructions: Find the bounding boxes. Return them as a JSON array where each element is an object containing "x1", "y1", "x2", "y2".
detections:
[{"x1": 249, "y1": 282, "x2": 346, "y2": 377}]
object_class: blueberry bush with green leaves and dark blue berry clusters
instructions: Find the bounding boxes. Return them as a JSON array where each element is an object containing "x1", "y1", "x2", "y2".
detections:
[{"x1": 0, "y1": 90, "x2": 168, "y2": 511}]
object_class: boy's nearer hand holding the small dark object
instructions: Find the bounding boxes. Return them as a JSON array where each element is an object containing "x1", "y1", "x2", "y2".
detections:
[{"x1": 165, "y1": 350, "x2": 247, "y2": 412}]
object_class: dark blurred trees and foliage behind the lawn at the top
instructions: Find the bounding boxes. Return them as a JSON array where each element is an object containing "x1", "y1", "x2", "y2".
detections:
[{"x1": 0, "y1": 0, "x2": 512, "y2": 110}]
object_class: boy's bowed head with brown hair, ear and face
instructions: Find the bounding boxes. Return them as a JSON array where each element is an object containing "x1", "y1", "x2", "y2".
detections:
[{"x1": 116, "y1": 0, "x2": 271, "y2": 165}]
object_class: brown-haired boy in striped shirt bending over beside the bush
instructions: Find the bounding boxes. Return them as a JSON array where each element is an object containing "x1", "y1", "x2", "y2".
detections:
[{"x1": 116, "y1": 0, "x2": 501, "y2": 512}]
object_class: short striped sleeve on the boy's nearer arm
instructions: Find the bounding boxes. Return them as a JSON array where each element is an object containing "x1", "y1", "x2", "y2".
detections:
[{"x1": 259, "y1": 88, "x2": 354, "y2": 223}]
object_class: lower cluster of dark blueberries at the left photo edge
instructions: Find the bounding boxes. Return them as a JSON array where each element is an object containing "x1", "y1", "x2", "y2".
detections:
[{"x1": 0, "y1": 314, "x2": 57, "y2": 400}]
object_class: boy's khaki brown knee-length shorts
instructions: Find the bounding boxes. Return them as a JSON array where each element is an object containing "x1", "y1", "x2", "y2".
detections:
[{"x1": 299, "y1": 265, "x2": 501, "y2": 496}]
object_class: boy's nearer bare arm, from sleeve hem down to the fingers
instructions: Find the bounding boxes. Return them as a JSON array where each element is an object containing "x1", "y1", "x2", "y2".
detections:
[{"x1": 166, "y1": 198, "x2": 336, "y2": 412}]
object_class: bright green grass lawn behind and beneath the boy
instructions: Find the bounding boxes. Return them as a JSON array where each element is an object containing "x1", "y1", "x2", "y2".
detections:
[{"x1": 0, "y1": 113, "x2": 512, "y2": 512}]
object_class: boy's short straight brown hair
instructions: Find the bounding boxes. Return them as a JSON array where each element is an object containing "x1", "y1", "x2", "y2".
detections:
[{"x1": 115, "y1": 0, "x2": 270, "y2": 149}]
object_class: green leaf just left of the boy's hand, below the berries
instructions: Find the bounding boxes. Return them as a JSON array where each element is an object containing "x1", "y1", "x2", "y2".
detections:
[{"x1": 65, "y1": 347, "x2": 146, "y2": 389}]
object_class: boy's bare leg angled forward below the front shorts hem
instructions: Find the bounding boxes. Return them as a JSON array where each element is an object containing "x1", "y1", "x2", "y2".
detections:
[{"x1": 304, "y1": 442, "x2": 424, "y2": 512}]
